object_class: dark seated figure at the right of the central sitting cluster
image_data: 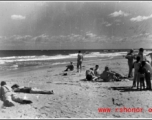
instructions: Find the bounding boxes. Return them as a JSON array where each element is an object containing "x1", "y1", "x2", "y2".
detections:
[{"x1": 100, "y1": 66, "x2": 120, "y2": 82}]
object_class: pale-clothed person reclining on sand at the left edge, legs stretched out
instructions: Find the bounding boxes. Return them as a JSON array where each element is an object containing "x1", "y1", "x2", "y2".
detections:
[{"x1": 0, "y1": 81, "x2": 32, "y2": 107}]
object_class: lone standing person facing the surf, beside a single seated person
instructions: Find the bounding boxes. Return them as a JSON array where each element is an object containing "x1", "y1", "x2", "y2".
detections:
[{"x1": 77, "y1": 51, "x2": 83, "y2": 72}]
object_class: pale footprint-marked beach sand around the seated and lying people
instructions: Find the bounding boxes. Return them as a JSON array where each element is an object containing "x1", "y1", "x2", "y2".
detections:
[{"x1": 0, "y1": 59, "x2": 152, "y2": 118}]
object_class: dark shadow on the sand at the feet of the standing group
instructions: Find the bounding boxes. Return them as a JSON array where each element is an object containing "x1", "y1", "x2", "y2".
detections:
[{"x1": 109, "y1": 86, "x2": 150, "y2": 92}]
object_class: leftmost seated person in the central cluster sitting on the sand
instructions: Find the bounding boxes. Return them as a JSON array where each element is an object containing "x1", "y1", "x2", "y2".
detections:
[{"x1": 86, "y1": 68, "x2": 97, "y2": 81}]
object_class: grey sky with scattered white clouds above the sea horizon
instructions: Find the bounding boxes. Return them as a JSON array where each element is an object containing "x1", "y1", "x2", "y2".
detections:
[{"x1": 0, "y1": 1, "x2": 152, "y2": 50}]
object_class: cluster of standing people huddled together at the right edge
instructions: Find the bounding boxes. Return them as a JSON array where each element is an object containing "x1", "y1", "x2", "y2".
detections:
[{"x1": 124, "y1": 48, "x2": 152, "y2": 90}]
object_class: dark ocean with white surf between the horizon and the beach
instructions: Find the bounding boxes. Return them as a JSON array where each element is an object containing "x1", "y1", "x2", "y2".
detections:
[{"x1": 0, "y1": 49, "x2": 150, "y2": 71}]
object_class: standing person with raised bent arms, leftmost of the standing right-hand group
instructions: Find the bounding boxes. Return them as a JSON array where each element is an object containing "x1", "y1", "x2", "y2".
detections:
[{"x1": 125, "y1": 49, "x2": 135, "y2": 78}]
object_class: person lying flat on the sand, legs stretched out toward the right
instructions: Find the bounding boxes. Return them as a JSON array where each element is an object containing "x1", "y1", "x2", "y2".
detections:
[{"x1": 11, "y1": 84, "x2": 53, "y2": 94}]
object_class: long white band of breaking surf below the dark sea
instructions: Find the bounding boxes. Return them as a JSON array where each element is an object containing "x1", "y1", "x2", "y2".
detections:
[{"x1": 0, "y1": 52, "x2": 126, "y2": 64}]
